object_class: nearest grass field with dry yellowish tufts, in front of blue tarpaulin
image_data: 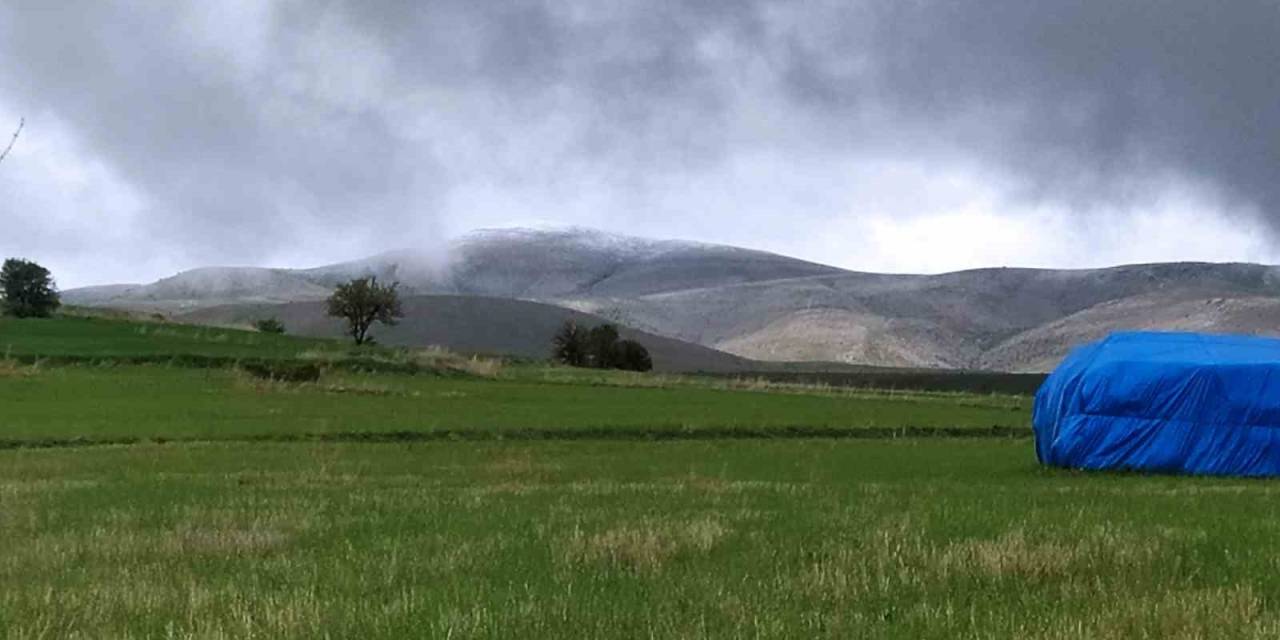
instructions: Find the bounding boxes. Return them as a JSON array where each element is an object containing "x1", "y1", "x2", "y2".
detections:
[{"x1": 0, "y1": 439, "x2": 1280, "y2": 639}]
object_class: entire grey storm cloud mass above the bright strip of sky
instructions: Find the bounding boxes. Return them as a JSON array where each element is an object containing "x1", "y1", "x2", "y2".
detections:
[{"x1": 0, "y1": 0, "x2": 1280, "y2": 282}]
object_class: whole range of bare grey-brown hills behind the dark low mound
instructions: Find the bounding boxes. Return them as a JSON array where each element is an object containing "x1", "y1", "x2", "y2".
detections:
[{"x1": 65, "y1": 229, "x2": 1280, "y2": 371}]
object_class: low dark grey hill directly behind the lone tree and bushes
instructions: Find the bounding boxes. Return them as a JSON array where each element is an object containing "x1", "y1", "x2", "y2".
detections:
[{"x1": 175, "y1": 296, "x2": 756, "y2": 372}]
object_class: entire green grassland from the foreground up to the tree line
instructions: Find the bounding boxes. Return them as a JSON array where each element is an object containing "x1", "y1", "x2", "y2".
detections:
[{"x1": 0, "y1": 319, "x2": 1280, "y2": 639}]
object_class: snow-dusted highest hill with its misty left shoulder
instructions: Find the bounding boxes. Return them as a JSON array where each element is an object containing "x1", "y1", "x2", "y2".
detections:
[{"x1": 72, "y1": 229, "x2": 845, "y2": 312}]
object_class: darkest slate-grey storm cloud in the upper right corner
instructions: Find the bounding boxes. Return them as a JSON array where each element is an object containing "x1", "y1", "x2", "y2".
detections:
[{"x1": 787, "y1": 0, "x2": 1280, "y2": 215}]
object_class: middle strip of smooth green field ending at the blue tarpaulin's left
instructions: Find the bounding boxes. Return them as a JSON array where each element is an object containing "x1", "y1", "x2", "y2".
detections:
[{"x1": 0, "y1": 365, "x2": 1027, "y2": 444}]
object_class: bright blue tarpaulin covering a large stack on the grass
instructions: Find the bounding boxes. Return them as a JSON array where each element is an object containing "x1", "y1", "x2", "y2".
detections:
[{"x1": 1032, "y1": 332, "x2": 1280, "y2": 476}]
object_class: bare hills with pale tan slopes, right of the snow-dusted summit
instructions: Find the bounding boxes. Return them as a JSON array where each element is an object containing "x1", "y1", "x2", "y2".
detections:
[{"x1": 578, "y1": 264, "x2": 1280, "y2": 371}]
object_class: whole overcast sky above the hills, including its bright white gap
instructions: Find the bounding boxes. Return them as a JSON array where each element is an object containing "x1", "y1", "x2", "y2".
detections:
[{"x1": 0, "y1": 0, "x2": 1280, "y2": 288}]
